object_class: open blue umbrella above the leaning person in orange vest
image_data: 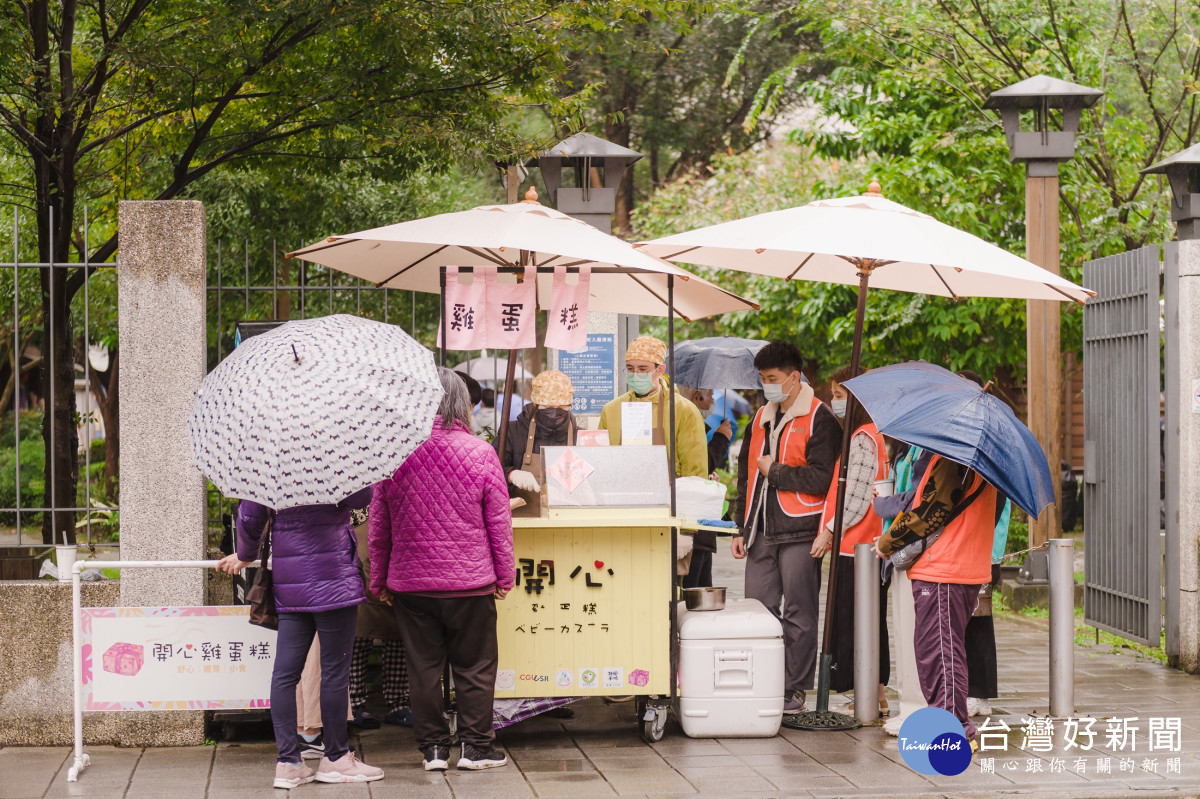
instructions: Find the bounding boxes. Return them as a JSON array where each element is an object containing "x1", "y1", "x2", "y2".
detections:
[{"x1": 845, "y1": 361, "x2": 1054, "y2": 518}]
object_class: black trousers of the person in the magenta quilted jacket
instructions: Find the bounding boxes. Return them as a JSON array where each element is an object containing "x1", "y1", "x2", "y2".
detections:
[{"x1": 392, "y1": 594, "x2": 498, "y2": 749}]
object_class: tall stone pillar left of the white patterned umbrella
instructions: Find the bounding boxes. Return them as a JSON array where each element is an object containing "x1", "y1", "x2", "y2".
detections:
[{"x1": 118, "y1": 200, "x2": 208, "y2": 607}]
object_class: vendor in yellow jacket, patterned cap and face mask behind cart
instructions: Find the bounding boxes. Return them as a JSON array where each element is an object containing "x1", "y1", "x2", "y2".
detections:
[{"x1": 600, "y1": 336, "x2": 708, "y2": 477}]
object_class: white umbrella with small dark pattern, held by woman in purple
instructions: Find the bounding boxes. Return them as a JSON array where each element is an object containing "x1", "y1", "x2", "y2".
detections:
[{"x1": 187, "y1": 314, "x2": 443, "y2": 510}]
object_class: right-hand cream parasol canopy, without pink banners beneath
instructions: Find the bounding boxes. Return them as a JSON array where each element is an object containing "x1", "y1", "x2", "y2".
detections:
[{"x1": 640, "y1": 184, "x2": 1096, "y2": 304}]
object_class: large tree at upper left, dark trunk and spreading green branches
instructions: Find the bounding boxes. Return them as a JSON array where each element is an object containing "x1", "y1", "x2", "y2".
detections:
[{"x1": 0, "y1": 0, "x2": 626, "y2": 541}]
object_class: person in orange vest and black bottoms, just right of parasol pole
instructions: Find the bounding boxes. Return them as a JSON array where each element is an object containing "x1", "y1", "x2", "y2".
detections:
[{"x1": 821, "y1": 366, "x2": 892, "y2": 716}]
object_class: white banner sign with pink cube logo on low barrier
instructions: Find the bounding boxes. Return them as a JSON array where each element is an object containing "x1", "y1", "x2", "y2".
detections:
[{"x1": 80, "y1": 606, "x2": 276, "y2": 710}]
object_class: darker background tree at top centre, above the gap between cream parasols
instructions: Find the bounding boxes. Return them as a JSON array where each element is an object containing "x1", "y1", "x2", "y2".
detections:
[{"x1": 559, "y1": 0, "x2": 823, "y2": 233}]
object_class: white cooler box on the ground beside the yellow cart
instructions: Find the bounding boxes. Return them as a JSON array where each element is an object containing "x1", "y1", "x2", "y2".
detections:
[{"x1": 677, "y1": 600, "x2": 784, "y2": 738}]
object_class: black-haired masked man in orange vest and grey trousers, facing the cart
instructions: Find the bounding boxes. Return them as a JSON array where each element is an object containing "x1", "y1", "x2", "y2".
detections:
[{"x1": 731, "y1": 341, "x2": 841, "y2": 714}]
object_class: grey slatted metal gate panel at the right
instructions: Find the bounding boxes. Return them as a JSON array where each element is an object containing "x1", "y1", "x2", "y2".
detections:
[{"x1": 1084, "y1": 246, "x2": 1162, "y2": 647}]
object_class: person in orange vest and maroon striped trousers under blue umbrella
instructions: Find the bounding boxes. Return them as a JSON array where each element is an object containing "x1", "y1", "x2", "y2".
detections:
[{"x1": 876, "y1": 455, "x2": 1007, "y2": 749}]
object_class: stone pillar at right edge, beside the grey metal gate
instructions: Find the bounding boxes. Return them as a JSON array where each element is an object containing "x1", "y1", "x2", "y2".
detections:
[{"x1": 1166, "y1": 240, "x2": 1200, "y2": 674}]
